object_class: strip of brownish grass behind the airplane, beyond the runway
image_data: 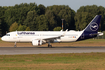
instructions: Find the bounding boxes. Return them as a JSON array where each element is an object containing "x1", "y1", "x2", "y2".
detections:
[{"x1": 0, "y1": 39, "x2": 105, "y2": 47}]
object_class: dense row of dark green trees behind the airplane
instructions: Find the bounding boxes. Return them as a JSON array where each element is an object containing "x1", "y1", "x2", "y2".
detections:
[{"x1": 0, "y1": 3, "x2": 105, "y2": 35}]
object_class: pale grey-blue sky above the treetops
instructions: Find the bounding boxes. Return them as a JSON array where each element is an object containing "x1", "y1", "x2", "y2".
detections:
[{"x1": 0, "y1": 0, "x2": 105, "y2": 11}]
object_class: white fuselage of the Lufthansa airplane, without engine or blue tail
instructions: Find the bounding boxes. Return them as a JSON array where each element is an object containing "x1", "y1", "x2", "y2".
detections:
[{"x1": 2, "y1": 31, "x2": 83, "y2": 42}]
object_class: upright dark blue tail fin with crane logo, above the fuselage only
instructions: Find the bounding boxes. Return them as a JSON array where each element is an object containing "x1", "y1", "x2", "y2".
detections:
[{"x1": 84, "y1": 15, "x2": 101, "y2": 32}]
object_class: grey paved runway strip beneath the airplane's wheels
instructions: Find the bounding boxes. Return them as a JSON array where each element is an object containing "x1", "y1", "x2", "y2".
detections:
[{"x1": 0, "y1": 47, "x2": 105, "y2": 55}]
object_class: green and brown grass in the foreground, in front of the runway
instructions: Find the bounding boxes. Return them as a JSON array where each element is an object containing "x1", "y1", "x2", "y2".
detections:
[{"x1": 0, "y1": 53, "x2": 105, "y2": 70}]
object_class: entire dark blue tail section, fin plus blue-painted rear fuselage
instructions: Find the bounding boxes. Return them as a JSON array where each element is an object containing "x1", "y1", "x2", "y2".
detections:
[{"x1": 78, "y1": 15, "x2": 101, "y2": 40}]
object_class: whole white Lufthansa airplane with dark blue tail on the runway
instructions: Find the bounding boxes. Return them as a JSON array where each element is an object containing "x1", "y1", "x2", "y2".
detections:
[{"x1": 1, "y1": 15, "x2": 103, "y2": 48}]
